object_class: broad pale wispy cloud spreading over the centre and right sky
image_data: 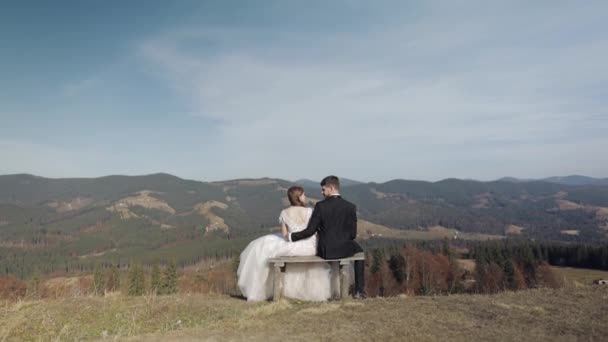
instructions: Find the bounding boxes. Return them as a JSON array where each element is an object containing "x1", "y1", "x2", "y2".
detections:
[{"x1": 139, "y1": 3, "x2": 608, "y2": 179}]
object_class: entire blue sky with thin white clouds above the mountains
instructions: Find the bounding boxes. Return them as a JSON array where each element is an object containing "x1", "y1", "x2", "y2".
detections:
[{"x1": 0, "y1": 0, "x2": 608, "y2": 181}]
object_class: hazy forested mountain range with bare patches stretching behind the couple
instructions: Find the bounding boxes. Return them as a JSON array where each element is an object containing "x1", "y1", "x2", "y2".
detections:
[{"x1": 0, "y1": 173, "x2": 608, "y2": 274}]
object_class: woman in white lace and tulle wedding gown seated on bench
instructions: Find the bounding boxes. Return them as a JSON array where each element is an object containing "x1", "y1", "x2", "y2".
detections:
[{"x1": 237, "y1": 186, "x2": 331, "y2": 301}]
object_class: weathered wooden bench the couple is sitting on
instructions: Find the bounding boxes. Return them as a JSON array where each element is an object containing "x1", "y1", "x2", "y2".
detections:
[{"x1": 268, "y1": 252, "x2": 365, "y2": 300}]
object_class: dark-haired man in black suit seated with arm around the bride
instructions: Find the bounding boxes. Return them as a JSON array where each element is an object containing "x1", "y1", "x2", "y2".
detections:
[{"x1": 289, "y1": 176, "x2": 365, "y2": 298}]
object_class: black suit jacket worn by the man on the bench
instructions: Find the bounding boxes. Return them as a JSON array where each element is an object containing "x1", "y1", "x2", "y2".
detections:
[{"x1": 291, "y1": 196, "x2": 363, "y2": 259}]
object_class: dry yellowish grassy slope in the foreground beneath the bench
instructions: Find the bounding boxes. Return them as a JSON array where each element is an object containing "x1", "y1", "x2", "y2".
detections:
[{"x1": 0, "y1": 286, "x2": 608, "y2": 341}]
